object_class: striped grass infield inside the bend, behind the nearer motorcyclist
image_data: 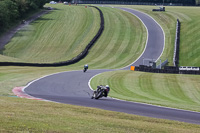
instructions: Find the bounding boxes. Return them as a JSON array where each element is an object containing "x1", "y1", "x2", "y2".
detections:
[{"x1": 91, "y1": 71, "x2": 200, "y2": 112}]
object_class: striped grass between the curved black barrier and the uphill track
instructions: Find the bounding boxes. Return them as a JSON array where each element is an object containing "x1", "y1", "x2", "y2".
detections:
[{"x1": 71, "y1": 7, "x2": 147, "y2": 69}]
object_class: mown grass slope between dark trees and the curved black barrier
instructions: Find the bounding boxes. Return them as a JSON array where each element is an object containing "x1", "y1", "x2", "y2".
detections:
[{"x1": 0, "y1": 4, "x2": 100, "y2": 63}]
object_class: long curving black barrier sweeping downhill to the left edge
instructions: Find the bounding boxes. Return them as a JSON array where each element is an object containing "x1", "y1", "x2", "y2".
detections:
[{"x1": 0, "y1": 6, "x2": 104, "y2": 67}]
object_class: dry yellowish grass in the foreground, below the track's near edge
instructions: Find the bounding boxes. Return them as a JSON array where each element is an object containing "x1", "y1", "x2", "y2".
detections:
[{"x1": 0, "y1": 97, "x2": 200, "y2": 133}]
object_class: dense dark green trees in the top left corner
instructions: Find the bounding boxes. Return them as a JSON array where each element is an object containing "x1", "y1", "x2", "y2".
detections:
[{"x1": 0, "y1": 0, "x2": 49, "y2": 32}]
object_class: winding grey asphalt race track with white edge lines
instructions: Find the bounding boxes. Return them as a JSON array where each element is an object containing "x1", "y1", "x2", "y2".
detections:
[{"x1": 24, "y1": 8, "x2": 200, "y2": 124}]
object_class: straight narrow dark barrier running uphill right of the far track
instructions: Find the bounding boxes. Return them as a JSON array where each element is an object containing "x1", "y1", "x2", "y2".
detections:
[{"x1": 173, "y1": 19, "x2": 181, "y2": 67}]
